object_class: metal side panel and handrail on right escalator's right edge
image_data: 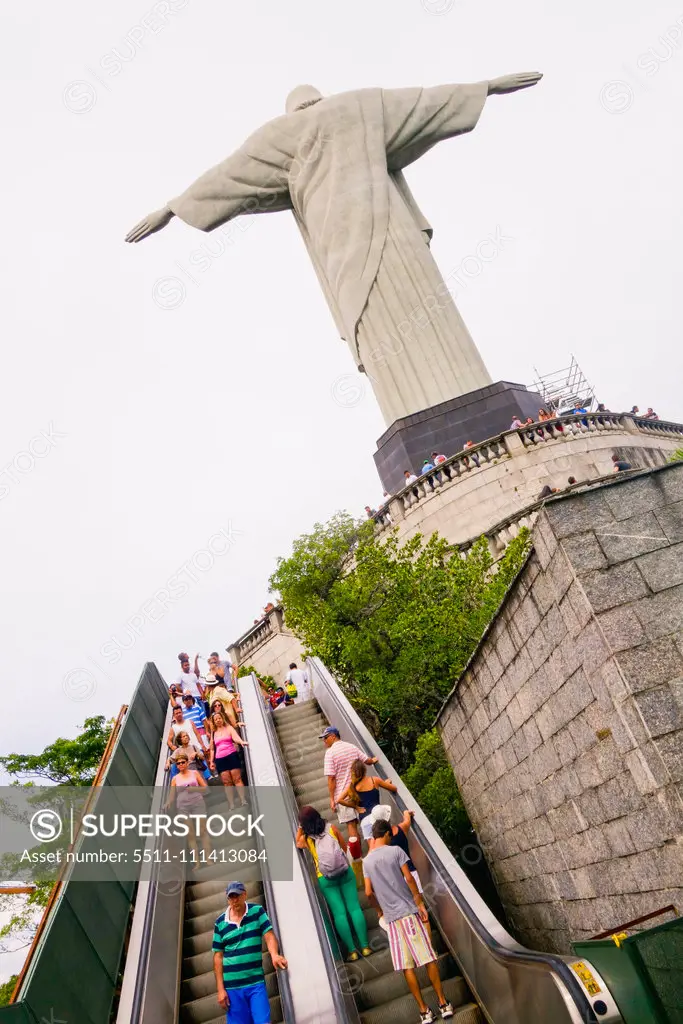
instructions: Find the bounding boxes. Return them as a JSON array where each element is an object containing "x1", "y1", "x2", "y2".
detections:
[{"x1": 306, "y1": 657, "x2": 622, "y2": 1024}]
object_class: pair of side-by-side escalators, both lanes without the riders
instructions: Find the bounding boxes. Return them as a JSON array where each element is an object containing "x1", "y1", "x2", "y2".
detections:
[{"x1": 117, "y1": 658, "x2": 622, "y2": 1024}]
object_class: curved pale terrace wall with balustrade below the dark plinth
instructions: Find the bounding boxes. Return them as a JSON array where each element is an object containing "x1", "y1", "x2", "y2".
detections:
[{"x1": 380, "y1": 413, "x2": 683, "y2": 544}]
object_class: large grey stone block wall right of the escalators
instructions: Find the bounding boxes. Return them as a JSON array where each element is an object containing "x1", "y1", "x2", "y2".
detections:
[{"x1": 438, "y1": 463, "x2": 683, "y2": 952}]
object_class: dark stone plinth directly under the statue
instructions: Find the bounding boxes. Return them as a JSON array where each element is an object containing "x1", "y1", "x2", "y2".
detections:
[{"x1": 375, "y1": 381, "x2": 543, "y2": 495}]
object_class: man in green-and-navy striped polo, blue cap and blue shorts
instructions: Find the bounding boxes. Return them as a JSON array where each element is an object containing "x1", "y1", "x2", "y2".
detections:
[{"x1": 213, "y1": 882, "x2": 287, "y2": 1024}]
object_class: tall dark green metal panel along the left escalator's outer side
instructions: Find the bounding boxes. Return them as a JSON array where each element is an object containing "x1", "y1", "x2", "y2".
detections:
[{"x1": 0, "y1": 664, "x2": 168, "y2": 1024}]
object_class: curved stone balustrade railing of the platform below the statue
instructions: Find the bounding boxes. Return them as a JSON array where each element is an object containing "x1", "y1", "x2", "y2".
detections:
[{"x1": 374, "y1": 412, "x2": 683, "y2": 527}]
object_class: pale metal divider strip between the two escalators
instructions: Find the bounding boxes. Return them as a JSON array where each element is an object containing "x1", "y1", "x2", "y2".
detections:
[{"x1": 240, "y1": 676, "x2": 359, "y2": 1024}]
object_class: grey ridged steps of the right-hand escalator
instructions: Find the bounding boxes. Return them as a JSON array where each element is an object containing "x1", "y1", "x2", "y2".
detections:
[{"x1": 273, "y1": 699, "x2": 483, "y2": 1024}]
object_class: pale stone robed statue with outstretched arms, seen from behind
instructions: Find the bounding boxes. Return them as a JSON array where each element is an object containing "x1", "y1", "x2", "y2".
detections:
[{"x1": 126, "y1": 73, "x2": 542, "y2": 425}]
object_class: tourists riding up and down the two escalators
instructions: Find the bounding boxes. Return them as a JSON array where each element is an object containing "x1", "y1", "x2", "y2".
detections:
[{"x1": 166, "y1": 651, "x2": 454, "y2": 1024}]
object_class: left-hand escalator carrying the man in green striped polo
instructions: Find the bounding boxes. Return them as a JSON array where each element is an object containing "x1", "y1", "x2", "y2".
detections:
[{"x1": 116, "y1": 675, "x2": 344, "y2": 1024}]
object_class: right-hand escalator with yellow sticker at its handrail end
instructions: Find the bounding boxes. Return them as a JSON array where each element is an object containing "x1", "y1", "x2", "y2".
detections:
[{"x1": 252, "y1": 658, "x2": 622, "y2": 1024}]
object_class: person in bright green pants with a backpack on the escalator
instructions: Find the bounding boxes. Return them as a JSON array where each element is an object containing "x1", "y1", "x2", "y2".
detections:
[{"x1": 296, "y1": 807, "x2": 373, "y2": 963}]
